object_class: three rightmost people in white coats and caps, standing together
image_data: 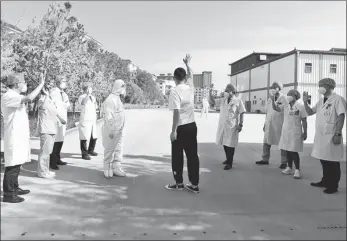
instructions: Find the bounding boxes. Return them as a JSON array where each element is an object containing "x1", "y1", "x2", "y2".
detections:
[{"x1": 256, "y1": 78, "x2": 346, "y2": 194}]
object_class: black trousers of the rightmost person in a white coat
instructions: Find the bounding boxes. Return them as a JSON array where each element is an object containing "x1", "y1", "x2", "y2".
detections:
[{"x1": 320, "y1": 160, "x2": 341, "y2": 190}]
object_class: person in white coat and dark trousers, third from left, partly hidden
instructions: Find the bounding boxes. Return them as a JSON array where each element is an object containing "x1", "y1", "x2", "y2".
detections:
[{"x1": 50, "y1": 75, "x2": 70, "y2": 170}]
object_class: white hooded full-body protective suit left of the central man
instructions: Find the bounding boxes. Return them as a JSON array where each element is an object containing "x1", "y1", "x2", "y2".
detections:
[{"x1": 101, "y1": 93, "x2": 125, "y2": 170}]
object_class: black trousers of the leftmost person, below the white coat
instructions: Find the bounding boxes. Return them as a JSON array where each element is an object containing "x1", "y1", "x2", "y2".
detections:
[{"x1": 2, "y1": 165, "x2": 22, "y2": 196}]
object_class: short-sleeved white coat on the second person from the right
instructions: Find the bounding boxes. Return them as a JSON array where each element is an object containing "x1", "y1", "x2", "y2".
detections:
[{"x1": 278, "y1": 101, "x2": 308, "y2": 152}]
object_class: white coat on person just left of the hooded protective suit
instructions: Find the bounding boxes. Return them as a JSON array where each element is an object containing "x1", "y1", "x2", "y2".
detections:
[{"x1": 78, "y1": 94, "x2": 97, "y2": 141}]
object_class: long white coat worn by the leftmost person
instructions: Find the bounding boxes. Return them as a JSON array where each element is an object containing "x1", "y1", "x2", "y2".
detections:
[{"x1": 1, "y1": 89, "x2": 31, "y2": 167}]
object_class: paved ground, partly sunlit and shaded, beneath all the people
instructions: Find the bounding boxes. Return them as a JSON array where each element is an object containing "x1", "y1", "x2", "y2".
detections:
[{"x1": 1, "y1": 110, "x2": 346, "y2": 240}]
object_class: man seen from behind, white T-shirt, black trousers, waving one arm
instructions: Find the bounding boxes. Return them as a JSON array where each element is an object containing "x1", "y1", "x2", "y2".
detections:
[{"x1": 165, "y1": 54, "x2": 200, "y2": 193}]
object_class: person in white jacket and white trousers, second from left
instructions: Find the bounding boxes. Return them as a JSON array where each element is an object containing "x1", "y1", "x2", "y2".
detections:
[{"x1": 37, "y1": 83, "x2": 66, "y2": 178}]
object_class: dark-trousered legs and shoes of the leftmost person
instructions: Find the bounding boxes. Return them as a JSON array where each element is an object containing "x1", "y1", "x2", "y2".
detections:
[{"x1": 3, "y1": 165, "x2": 27, "y2": 203}]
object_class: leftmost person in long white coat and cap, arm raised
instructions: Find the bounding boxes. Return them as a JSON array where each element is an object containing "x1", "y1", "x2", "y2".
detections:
[{"x1": 1, "y1": 74, "x2": 45, "y2": 203}]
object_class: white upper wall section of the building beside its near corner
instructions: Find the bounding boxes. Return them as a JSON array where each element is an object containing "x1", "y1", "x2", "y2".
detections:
[{"x1": 270, "y1": 54, "x2": 295, "y2": 85}]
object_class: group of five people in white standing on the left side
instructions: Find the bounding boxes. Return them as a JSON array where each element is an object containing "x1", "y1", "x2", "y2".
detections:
[{"x1": 1, "y1": 73, "x2": 126, "y2": 203}]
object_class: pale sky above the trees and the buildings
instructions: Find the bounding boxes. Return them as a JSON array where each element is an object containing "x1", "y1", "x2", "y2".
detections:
[{"x1": 1, "y1": 1, "x2": 346, "y2": 91}]
